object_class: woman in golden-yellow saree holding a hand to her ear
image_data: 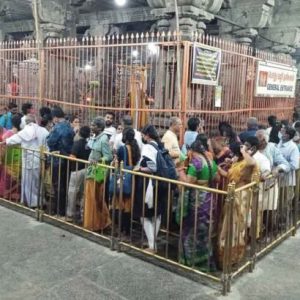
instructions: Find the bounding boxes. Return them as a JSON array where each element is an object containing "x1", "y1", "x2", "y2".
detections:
[{"x1": 218, "y1": 143, "x2": 258, "y2": 267}]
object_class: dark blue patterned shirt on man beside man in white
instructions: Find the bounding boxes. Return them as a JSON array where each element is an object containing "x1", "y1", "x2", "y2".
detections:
[{"x1": 47, "y1": 121, "x2": 75, "y2": 156}]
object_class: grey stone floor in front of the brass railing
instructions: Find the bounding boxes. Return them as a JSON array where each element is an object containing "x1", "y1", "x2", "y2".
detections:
[{"x1": 0, "y1": 207, "x2": 300, "y2": 300}]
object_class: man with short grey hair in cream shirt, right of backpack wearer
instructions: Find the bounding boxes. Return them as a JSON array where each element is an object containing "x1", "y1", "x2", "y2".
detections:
[{"x1": 162, "y1": 117, "x2": 182, "y2": 164}]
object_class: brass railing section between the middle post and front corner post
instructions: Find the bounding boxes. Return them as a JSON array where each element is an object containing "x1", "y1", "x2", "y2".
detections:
[{"x1": 112, "y1": 164, "x2": 227, "y2": 292}]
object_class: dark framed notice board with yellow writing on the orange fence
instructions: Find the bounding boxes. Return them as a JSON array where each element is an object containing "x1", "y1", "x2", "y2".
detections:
[{"x1": 192, "y1": 43, "x2": 222, "y2": 85}]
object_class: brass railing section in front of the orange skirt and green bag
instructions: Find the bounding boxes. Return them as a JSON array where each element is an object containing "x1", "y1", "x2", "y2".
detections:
[{"x1": 41, "y1": 151, "x2": 113, "y2": 241}]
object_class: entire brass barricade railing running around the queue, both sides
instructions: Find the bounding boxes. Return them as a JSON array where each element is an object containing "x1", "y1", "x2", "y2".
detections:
[{"x1": 0, "y1": 146, "x2": 300, "y2": 294}]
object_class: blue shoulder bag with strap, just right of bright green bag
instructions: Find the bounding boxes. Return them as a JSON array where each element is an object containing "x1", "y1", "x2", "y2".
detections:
[{"x1": 109, "y1": 146, "x2": 133, "y2": 196}]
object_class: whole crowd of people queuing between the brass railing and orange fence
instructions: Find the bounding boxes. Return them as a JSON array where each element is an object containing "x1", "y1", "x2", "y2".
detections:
[{"x1": 0, "y1": 103, "x2": 300, "y2": 269}]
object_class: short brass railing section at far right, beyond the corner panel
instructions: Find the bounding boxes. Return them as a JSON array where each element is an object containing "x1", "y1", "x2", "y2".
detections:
[{"x1": 255, "y1": 171, "x2": 299, "y2": 256}]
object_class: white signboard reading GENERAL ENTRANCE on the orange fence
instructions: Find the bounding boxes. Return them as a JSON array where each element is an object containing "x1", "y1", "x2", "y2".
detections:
[{"x1": 255, "y1": 61, "x2": 297, "y2": 97}]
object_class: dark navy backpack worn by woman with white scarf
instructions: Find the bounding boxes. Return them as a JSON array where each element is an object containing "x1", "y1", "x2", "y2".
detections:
[{"x1": 150, "y1": 143, "x2": 178, "y2": 180}]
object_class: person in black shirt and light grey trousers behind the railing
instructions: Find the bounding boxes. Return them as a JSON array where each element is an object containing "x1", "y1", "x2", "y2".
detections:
[{"x1": 67, "y1": 126, "x2": 91, "y2": 221}]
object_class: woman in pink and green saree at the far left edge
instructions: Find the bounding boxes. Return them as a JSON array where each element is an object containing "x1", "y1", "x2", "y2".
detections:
[{"x1": 0, "y1": 114, "x2": 22, "y2": 202}]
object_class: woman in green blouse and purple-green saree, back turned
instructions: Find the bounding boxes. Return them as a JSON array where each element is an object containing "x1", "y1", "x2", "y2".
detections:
[{"x1": 176, "y1": 139, "x2": 218, "y2": 271}]
